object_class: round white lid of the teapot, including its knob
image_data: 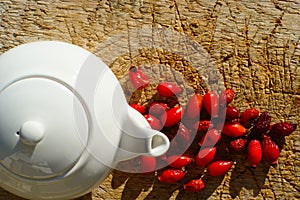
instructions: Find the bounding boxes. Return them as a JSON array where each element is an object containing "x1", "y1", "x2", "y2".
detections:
[{"x1": 0, "y1": 42, "x2": 89, "y2": 180}]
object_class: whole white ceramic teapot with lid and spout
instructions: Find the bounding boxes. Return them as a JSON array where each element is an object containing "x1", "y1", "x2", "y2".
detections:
[{"x1": 0, "y1": 41, "x2": 169, "y2": 199}]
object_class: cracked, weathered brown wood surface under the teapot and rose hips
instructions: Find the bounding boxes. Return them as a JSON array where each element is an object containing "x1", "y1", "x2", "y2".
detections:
[{"x1": 0, "y1": 0, "x2": 300, "y2": 200}]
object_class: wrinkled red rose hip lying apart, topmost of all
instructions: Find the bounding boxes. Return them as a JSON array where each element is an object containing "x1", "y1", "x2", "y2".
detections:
[{"x1": 129, "y1": 66, "x2": 149, "y2": 89}]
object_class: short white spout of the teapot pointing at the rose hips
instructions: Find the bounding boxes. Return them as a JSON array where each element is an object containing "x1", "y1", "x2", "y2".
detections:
[{"x1": 115, "y1": 106, "x2": 170, "y2": 162}]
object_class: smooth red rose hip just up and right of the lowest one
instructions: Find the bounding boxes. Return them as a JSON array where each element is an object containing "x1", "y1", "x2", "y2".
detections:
[{"x1": 207, "y1": 160, "x2": 233, "y2": 176}]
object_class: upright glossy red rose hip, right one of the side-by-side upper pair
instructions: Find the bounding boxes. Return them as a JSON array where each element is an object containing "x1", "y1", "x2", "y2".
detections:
[{"x1": 203, "y1": 91, "x2": 219, "y2": 117}]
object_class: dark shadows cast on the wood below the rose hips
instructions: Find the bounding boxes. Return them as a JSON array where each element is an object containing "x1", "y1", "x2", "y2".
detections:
[{"x1": 112, "y1": 127, "x2": 270, "y2": 200}]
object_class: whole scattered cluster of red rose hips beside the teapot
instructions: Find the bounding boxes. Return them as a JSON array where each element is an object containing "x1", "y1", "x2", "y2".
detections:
[{"x1": 129, "y1": 67, "x2": 296, "y2": 192}]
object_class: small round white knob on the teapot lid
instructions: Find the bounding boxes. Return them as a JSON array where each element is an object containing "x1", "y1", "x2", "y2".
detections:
[{"x1": 19, "y1": 121, "x2": 44, "y2": 145}]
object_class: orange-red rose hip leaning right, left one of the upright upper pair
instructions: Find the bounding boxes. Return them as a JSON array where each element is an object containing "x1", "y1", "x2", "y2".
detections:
[{"x1": 187, "y1": 93, "x2": 202, "y2": 119}]
